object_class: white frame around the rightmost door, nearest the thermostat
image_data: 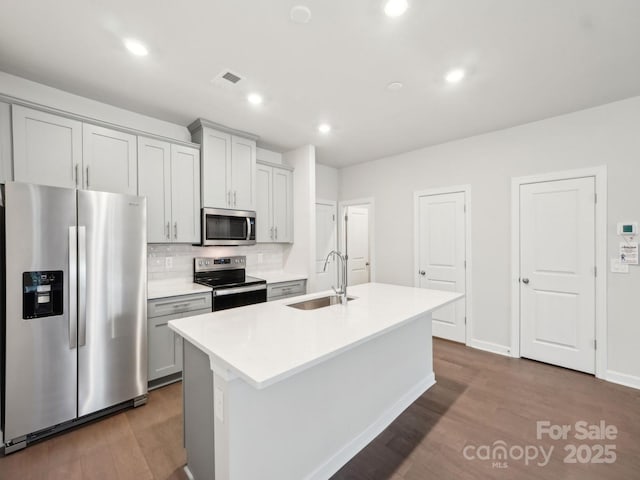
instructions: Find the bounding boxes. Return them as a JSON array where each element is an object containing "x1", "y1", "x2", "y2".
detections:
[{"x1": 509, "y1": 165, "x2": 607, "y2": 378}]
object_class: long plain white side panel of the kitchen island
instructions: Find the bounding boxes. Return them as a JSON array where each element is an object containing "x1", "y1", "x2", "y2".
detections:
[{"x1": 185, "y1": 314, "x2": 434, "y2": 480}]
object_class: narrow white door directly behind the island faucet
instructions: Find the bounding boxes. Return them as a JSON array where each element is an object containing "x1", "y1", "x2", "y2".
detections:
[{"x1": 316, "y1": 203, "x2": 338, "y2": 291}]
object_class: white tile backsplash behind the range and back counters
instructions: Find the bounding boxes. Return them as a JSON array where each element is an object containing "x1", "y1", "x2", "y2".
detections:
[{"x1": 147, "y1": 243, "x2": 289, "y2": 280}]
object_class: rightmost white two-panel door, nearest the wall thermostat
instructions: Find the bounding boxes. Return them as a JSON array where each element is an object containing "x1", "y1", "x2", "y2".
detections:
[{"x1": 520, "y1": 177, "x2": 595, "y2": 373}]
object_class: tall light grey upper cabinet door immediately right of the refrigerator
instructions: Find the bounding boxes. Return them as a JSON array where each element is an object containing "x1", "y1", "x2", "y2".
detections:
[{"x1": 138, "y1": 137, "x2": 171, "y2": 243}]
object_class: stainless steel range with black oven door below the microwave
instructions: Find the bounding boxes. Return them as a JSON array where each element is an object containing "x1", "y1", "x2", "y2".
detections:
[{"x1": 193, "y1": 256, "x2": 267, "y2": 312}]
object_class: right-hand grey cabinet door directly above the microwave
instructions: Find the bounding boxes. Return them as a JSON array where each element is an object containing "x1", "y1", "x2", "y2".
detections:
[{"x1": 231, "y1": 135, "x2": 256, "y2": 210}]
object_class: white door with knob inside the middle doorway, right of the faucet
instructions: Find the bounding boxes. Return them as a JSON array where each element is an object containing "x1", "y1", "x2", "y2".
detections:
[{"x1": 347, "y1": 206, "x2": 369, "y2": 285}]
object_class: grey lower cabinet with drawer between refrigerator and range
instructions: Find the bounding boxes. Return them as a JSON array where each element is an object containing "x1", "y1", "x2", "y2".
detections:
[{"x1": 147, "y1": 293, "x2": 211, "y2": 388}]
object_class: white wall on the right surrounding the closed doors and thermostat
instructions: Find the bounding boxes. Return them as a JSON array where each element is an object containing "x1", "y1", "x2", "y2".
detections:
[{"x1": 340, "y1": 97, "x2": 640, "y2": 387}]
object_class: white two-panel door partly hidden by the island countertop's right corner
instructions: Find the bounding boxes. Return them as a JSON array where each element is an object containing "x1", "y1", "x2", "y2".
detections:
[{"x1": 418, "y1": 192, "x2": 466, "y2": 342}]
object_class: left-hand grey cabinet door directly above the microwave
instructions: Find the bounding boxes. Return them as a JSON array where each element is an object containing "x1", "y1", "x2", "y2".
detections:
[{"x1": 201, "y1": 128, "x2": 231, "y2": 208}]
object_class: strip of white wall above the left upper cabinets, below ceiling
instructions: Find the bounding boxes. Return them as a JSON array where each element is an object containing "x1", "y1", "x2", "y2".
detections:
[{"x1": 0, "y1": 72, "x2": 191, "y2": 142}]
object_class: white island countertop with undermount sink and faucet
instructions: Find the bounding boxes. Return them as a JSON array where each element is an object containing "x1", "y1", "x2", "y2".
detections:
[{"x1": 169, "y1": 283, "x2": 463, "y2": 389}]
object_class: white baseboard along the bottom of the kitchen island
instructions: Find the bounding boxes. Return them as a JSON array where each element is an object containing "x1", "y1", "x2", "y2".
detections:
[{"x1": 306, "y1": 373, "x2": 436, "y2": 480}]
